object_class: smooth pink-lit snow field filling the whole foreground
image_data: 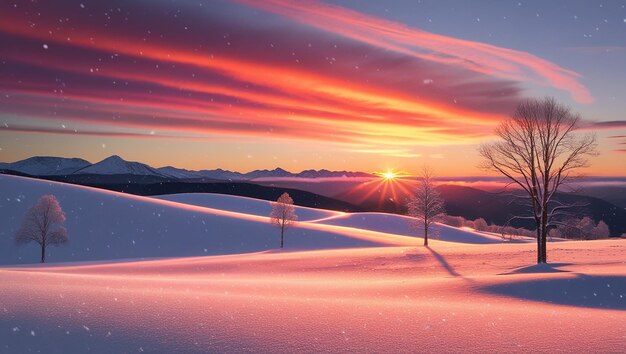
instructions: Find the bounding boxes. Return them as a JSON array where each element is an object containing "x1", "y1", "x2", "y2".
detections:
[{"x1": 0, "y1": 240, "x2": 626, "y2": 353}]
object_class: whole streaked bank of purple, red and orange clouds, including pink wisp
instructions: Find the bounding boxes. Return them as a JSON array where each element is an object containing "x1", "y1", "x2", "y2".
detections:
[{"x1": 0, "y1": 0, "x2": 591, "y2": 158}]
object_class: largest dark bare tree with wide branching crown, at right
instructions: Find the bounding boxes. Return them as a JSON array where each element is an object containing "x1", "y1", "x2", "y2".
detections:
[{"x1": 480, "y1": 98, "x2": 597, "y2": 263}]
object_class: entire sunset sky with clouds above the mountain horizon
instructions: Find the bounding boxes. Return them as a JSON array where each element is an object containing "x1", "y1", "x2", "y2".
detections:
[{"x1": 0, "y1": 0, "x2": 626, "y2": 176}]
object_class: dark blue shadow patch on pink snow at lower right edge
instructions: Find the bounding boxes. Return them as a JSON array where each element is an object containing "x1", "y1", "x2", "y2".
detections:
[{"x1": 480, "y1": 274, "x2": 626, "y2": 311}]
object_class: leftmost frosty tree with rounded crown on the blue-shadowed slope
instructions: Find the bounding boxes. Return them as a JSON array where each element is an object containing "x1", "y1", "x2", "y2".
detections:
[{"x1": 15, "y1": 195, "x2": 67, "y2": 263}]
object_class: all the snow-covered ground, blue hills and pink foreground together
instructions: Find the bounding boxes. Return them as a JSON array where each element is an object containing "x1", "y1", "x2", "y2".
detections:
[{"x1": 0, "y1": 176, "x2": 626, "y2": 353}]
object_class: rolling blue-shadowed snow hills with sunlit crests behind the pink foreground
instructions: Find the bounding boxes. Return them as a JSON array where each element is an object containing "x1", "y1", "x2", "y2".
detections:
[{"x1": 0, "y1": 175, "x2": 502, "y2": 264}]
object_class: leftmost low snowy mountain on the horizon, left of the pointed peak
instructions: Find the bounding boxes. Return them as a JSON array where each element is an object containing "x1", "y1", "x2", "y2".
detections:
[{"x1": 0, "y1": 156, "x2": 91, "y2": 176}]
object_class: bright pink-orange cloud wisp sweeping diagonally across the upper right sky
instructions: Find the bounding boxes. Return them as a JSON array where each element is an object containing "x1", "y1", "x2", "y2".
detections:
[{"x1": 238, "y1": 0, "x2": 593, "y2": 103}]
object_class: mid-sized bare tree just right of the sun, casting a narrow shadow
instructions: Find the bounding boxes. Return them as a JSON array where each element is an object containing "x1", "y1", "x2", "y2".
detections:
[{"x1": 408, "y1": 167, "x2": 445, "y2": 246}]
